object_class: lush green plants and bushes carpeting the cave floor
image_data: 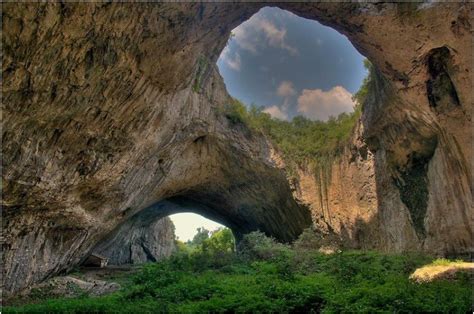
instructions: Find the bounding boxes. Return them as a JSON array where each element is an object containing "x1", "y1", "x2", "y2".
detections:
[{"x1": 3, "y1": 229, "x2": 472, "y2": 313}]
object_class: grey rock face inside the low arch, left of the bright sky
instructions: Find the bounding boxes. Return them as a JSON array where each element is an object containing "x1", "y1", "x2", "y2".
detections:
[{"x1": 93, "y1": 207, "x2": 175, "y2": 265}]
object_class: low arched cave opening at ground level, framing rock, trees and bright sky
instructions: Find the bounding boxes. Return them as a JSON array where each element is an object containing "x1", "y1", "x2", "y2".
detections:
[{"x1": 88, "y1": 197, "x2": 237, "y2": 267}]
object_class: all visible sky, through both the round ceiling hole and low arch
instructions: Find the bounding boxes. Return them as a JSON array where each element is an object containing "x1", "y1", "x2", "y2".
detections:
[{"x1": 170, "y1": 7, "x2": 366, "y2": 241}]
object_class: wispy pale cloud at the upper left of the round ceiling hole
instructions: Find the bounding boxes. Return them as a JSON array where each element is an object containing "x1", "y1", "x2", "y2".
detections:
[{"x1": 232, "y1": 15, "x2": 298, "y2": 55}]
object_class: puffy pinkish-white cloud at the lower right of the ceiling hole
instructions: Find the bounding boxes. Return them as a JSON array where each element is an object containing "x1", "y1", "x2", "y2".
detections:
[{"x1": 297, "y1": 86, "x2": 354, "y2": 121}]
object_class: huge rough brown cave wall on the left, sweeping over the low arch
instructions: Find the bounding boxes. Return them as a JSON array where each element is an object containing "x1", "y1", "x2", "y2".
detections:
[{"x1": 2, "y1": 3, "x2": 311, "y2": 292}]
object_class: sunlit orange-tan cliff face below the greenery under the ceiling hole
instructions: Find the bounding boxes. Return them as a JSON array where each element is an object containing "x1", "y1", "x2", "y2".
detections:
[{"x1": 291, "y1": 121, "x2": 381, "y2": 248}]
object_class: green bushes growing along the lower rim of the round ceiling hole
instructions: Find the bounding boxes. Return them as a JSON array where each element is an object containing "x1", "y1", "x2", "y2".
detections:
[{"x1": 222, "y1": 60, "x2": 374, "y2": 178}]
